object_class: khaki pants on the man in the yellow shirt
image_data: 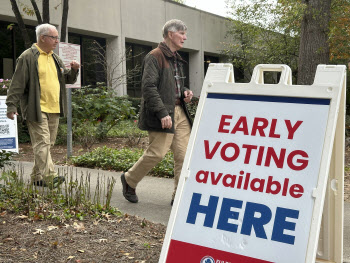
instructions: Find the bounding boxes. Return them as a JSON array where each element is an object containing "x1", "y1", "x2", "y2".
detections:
[{"x1": 27, "y1": 112, "x2": 60, "y2": 182}]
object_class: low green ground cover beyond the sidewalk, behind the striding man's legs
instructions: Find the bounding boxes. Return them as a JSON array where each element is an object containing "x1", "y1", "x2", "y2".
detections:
[{"x1": 72, "y1": 146, "x2": 174, "y2": 177}]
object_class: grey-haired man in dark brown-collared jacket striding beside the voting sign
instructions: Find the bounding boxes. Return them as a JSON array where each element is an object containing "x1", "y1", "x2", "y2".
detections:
[{"x1": 121, "y1": 19, "x2": 193, "y2": 205}]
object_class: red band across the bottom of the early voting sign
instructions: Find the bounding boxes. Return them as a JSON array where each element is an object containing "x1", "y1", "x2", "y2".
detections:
[{"x1": 166, "y1": 239, "x2": 272, "y2": 263}]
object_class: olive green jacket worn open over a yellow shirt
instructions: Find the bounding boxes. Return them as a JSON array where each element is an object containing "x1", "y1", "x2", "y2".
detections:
[{"x1": 6, "y1": 44, "x2": 78, "y2": 122}]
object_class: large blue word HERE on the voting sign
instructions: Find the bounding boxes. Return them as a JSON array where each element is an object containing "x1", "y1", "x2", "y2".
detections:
[{"x1": 186, "y1": 193, "x2": 299, "y2": 245}]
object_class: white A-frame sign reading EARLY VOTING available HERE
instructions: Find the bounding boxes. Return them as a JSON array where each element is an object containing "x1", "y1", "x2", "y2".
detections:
[{"x1": 159, "y1": 64, "x2": 346, "y2": 263}]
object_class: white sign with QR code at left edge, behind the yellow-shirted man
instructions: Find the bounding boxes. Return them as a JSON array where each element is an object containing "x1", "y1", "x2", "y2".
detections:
[{"x1": 0, "y1": 96, "x2": 18, "y2": 153}]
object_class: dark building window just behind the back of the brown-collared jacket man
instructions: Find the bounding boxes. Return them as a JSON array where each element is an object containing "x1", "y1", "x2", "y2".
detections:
[{"x1": 125, "y1": 42, "x2": 152, "y2": 98}]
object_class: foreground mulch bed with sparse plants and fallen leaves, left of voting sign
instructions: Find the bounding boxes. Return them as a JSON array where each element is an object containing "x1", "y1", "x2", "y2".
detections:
[{"x1": 0, "y1": 160, "x2": 165, "y2": 263}]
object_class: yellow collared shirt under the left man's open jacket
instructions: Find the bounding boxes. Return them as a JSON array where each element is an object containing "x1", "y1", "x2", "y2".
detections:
[{"x1": 35, "y1": 44, "x2": 60, "y2": 113}]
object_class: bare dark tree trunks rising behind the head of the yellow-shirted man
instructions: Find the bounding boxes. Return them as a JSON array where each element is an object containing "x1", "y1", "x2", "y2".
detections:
[{"x1": 10, "y1": 0, "x2": 69, "y2": 48}]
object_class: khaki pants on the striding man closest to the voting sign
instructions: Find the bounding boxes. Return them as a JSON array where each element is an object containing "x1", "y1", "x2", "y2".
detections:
[{"x1": 125, "y1": 106, "x2": 191, "y2": 197}]
